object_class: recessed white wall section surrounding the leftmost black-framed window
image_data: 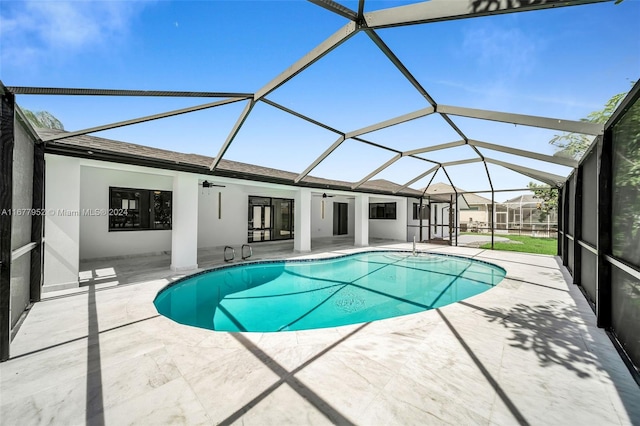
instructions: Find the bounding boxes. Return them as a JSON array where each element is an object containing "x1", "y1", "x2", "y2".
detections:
[{"x1": 78, "y1": 166, "x2": 173, "y2": 260}]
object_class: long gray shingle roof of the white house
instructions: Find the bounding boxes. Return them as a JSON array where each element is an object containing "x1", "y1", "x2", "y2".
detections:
[{"x1": 36, "y1": 128, "x2": 422, "y2": 197}]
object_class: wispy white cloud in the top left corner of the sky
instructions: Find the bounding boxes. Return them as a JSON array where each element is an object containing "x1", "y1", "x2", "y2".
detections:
[{"x1": 0, "y1": 0, "x2": 147, "y2": 64}]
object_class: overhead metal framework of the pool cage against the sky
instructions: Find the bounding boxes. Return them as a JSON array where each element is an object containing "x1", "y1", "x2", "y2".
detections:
[{"x1": 9, "y1": 0, "x2": 610, "y2": 193}]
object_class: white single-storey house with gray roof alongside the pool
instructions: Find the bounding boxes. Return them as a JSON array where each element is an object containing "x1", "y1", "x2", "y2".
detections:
[{"x1": 28, "y1": 123, "x2": 450, "y2": 290}]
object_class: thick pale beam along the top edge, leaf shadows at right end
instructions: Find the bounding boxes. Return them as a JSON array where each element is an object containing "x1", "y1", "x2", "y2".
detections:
[{"x1": 364, "y1": 0, "x2": 612, "y2": 28}]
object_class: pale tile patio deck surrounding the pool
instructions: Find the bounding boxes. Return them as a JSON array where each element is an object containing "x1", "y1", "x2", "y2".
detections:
[{"x1": 0, "y1": 240, "x2": 640, "y2": 425}]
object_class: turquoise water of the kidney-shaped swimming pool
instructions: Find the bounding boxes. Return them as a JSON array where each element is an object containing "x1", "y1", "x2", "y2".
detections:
[{"x1": 154, "y1": 251, "x2": 505, "y2": 332}]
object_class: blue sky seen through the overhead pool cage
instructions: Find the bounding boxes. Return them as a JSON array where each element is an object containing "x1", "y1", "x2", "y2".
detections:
[{"x1": 0, "y1": 0, "x2": 640, "y2": 195}]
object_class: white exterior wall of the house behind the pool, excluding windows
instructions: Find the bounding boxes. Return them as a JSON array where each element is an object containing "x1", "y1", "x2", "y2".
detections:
[{"x1": 45, "y1": 154, "x2": 418, "y2": 290}]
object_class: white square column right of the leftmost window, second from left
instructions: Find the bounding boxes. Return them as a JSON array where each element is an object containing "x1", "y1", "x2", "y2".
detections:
[{"x1": 171, "y1": 173, "x2": 198, "y2": 271}]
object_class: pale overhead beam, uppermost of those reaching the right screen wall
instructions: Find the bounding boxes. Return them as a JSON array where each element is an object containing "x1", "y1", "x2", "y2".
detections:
[{"x1": 436, "y1": 105, "x2": 604, "y2": 135}]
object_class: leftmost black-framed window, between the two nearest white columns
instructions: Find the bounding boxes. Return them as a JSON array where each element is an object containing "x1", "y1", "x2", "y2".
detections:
[{"x1": 109, "y1": 187, "x2": 172, "y2": 231}]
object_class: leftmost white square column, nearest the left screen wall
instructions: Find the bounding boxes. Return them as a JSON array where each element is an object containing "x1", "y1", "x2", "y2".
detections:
[{"x1": 43, "y1": 155, "x2": 80, "y2": 291}]
